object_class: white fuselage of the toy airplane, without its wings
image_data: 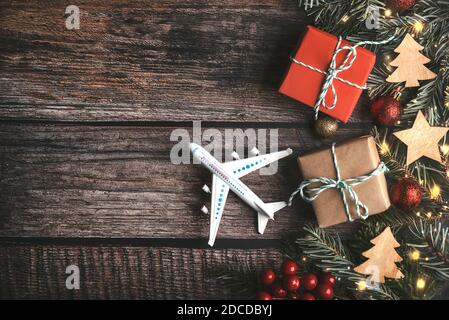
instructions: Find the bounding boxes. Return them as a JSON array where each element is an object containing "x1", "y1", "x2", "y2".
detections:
[{"x1": 192, "y1": 145, "x2": 273, "y2": 218}]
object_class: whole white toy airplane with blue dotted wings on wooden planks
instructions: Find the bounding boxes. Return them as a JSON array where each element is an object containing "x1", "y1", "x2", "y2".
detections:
[{"x1": 190, "y1": 143, "x2": 292, "y2": 246}]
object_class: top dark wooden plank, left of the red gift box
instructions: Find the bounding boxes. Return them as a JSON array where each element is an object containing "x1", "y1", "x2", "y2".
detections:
[{"x1": 0, "y1": 0, "x2": 368, "y2": 123}]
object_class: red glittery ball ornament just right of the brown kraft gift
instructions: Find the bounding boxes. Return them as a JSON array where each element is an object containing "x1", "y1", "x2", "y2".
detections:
[{"x1": 391, "y1": 178, "x2": 423, "y2": 210}]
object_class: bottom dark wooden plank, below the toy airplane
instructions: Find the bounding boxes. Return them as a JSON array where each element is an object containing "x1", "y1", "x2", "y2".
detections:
[{"x1": 0, "y1": 244, "x2": 281, "y2": 299}]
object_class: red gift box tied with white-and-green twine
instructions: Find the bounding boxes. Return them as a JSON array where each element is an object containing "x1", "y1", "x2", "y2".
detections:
[{"x1": 279, "y1": 26, "x2": 376, "y2": 123}]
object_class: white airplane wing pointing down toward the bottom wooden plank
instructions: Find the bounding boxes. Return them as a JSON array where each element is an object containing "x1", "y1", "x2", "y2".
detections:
[{"x1": 208, "y1": 175, "x2": 229, "y2": 247}]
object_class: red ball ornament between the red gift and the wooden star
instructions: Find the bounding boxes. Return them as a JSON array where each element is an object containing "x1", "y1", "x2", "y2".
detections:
[{"x1": 370, "y1": 96, "x2": 402, "y2": 126}]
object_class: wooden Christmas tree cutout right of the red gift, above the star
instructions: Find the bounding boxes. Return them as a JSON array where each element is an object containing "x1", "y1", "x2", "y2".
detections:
[{"x1": 387, "y1": 34, "x2": 437, "y2": 87}]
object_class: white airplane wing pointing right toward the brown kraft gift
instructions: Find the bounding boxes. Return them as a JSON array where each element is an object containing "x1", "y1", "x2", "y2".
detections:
[{"x1": 223, "y1": 148, "x2": 292, "y2": 178}]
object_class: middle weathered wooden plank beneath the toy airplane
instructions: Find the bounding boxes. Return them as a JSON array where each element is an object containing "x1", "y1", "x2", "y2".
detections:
[{"x1": 0, "y1": 123, "x2": 368, "y2": 239}]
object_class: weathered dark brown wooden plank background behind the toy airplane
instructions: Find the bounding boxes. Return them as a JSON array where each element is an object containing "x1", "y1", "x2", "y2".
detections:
[{"x1": 0, "y1": 0, "x2": 430, "y2": 299}]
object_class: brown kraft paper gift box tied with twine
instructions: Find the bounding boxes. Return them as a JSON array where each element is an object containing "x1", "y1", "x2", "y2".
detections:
[{"x1": 298, "y1": 136, "x2": 391, "y2": 228}]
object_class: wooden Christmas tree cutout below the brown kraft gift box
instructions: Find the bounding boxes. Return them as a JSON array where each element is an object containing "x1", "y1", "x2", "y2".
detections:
[{"x1": 354, "y1": 227, "x2": 404, "y2": 283}]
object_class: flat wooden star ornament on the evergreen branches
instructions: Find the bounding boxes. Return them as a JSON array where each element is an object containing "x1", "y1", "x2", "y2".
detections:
[{"x1": 393, "y1": 111, "x2": 449, "y2": 166}]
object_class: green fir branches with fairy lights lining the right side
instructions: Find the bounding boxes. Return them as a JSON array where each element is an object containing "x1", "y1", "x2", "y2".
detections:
[{"x1": 296, "y1": 0, "x2": 449, "y2": 299}]
